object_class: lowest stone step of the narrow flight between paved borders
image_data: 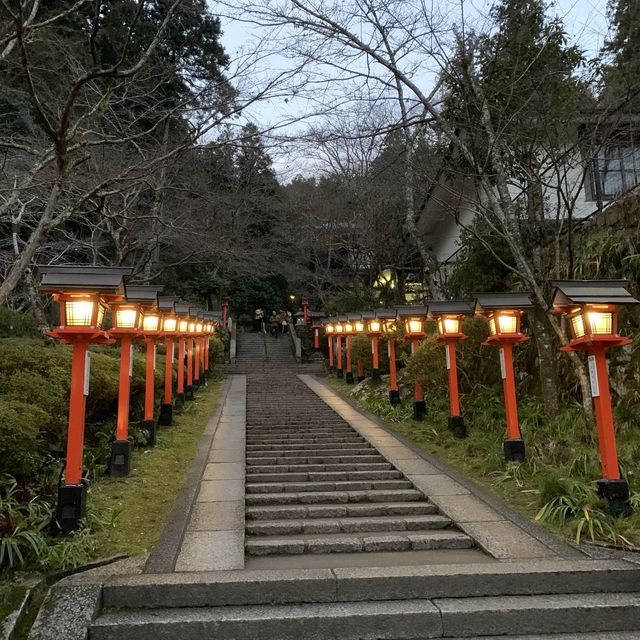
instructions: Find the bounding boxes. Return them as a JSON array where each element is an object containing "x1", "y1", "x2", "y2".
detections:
[{"x1": 245, "y1": 531, "x2": 475, "y2": 556}]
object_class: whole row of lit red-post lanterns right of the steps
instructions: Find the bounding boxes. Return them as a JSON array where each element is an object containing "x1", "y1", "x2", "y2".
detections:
[{"x1": 312, "y1": 280, "x2": 639, "y2": 515}]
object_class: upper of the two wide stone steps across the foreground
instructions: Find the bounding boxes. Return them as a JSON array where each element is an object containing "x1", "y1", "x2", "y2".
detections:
[{"x1": 103, "y1": 558, "x2": 640, "y2": 608}]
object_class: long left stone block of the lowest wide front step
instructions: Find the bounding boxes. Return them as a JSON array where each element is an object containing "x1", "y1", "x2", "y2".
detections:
[{"x1": 90, "y1": 600, "x2": 441, "y2": 640}]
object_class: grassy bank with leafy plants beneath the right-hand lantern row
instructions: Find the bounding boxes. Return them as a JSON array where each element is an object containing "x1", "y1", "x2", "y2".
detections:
[{"x1": 325, "y1": 377, "x2": 640, "y2": 549}]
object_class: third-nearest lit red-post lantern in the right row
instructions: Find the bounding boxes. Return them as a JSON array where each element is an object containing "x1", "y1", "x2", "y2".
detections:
[{"x1": 427, "y1": 300, "x2": 471, "y2": 438}]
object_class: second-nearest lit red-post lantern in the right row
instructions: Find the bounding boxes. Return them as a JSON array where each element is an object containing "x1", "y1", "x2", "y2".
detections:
[{"x1": 473, "y1": 292, "x2": 533, "y2": 462}]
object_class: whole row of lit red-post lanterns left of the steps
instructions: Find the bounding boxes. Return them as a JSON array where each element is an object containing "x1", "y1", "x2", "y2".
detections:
[{"x1": 39, "y1": 265, "x2": 227, "y2": 533}]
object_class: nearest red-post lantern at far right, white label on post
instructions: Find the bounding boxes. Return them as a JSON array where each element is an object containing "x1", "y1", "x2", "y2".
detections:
[{"x1": 551, "y1": 280, "x2": 639, "y2": 516}]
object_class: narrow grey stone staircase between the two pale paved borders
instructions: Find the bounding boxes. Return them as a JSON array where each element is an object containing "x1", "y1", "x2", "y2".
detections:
[{"x1": 245, "y1": 372, "x2": 475, "y2": 566}]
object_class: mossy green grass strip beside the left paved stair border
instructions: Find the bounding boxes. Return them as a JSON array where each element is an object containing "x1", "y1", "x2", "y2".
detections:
[{"x1": 87, "y1": 379, "x2": 223, "y2": 557}]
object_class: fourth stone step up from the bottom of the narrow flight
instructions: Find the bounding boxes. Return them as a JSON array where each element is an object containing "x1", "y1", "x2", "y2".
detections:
[{"x1": 245, "y1": 489, "x2": 425, "y2": 506}]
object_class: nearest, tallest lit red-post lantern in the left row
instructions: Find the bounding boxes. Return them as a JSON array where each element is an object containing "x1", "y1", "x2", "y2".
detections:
[{"x1": 38, "y1": 265, "x2": 132, "y2": 533}]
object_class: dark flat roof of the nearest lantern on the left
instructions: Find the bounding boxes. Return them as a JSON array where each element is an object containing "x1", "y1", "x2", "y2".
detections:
[{"x1": 38, "y1": 264, "x2": 133, "y2": 295}]
